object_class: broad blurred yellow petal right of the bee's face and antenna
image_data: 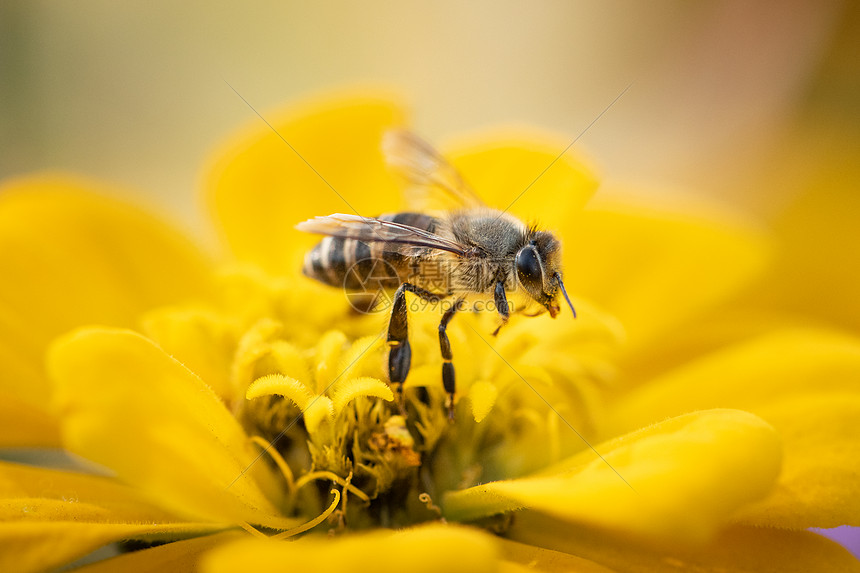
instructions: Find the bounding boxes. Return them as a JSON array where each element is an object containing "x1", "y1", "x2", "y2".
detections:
[{"x1": 563, "y1": 201, "x2": 769, "y2": 354}]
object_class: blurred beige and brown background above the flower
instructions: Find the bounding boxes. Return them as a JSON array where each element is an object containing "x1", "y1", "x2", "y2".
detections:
[{"x1": 0, "y1": 0, "x2": 860, "y2": 222}]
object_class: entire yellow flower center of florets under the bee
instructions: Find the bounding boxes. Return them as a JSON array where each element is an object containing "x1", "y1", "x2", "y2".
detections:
[{"x1": 147, "y1": 266, "x2": 614, "y2": 529}]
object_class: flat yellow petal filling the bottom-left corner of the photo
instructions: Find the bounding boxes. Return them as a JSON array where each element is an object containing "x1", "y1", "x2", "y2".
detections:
[{"x1": 0, "y1": 521, "x2": 218, "y2": 573}]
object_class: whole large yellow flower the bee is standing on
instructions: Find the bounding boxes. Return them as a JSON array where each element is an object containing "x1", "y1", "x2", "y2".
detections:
[{"x1": 0, "y1": 91, "x2": 860, "y2": 572}]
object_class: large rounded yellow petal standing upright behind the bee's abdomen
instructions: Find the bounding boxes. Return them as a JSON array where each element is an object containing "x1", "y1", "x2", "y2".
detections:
[{"x1": 206, "y1": 92, "x2": 410, "y2": 275}]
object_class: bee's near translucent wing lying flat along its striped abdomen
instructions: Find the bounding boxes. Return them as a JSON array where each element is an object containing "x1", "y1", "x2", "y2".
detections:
[{"x1": 296, "y1": 213, "x2": 467, "y2": 256}]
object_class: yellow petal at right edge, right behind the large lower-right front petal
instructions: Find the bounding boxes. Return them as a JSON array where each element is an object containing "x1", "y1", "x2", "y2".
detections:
[{"x1": 739, "y1": 392, "x2": 860, "y2": 529}]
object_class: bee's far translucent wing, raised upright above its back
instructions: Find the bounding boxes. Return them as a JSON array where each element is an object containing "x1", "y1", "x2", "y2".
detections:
[{"x1": 382, "y1": 130, "x2": 484, "y2": 211}]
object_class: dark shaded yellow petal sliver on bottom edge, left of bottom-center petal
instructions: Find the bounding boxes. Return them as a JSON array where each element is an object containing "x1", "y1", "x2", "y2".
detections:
[{"x1": 70, "y1": 531, "x2": 244, "y2": 573}]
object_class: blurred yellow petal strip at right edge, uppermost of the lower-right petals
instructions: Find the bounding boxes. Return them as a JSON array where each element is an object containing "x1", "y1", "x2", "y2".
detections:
[{"x1": 606, "y1": 329, "x2": 860, "y2": 435}]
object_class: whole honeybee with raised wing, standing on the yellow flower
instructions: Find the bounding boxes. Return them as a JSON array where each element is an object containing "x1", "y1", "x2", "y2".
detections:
[{"x1": 296, "y1": 131, "x2": 576, "y2": 417}]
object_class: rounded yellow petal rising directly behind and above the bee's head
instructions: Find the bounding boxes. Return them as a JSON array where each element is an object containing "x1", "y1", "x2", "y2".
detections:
[{"x1": 448, "y1": 129, "x2": 597, "y2": 230}]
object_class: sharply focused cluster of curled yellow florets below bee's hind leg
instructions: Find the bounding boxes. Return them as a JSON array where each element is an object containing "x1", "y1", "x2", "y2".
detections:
[{"x1": 234, "y1": 319, "x2": 456, "y2": 528}]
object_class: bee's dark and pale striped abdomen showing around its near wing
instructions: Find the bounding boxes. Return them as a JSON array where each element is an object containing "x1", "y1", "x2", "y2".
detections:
[{"x1": 302, "y1": 213, "x2": 439, "y2": 291}]
